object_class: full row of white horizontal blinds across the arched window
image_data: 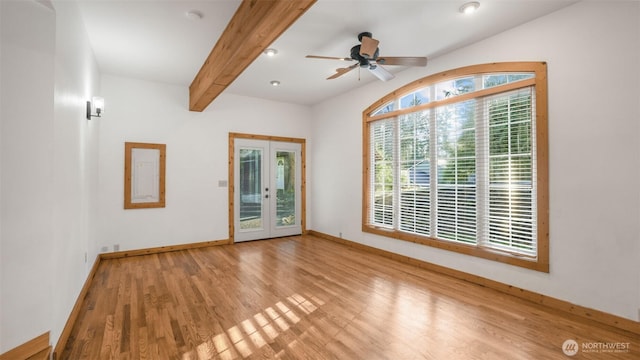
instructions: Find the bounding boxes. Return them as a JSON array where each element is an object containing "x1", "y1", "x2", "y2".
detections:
[{"x1": 368, "y1": 77, "x2": 537, "y2": 257}]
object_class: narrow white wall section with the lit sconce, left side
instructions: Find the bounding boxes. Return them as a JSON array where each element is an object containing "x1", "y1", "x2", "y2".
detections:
[{"x1": 50, "y1": 0, "x2": 100, "y2": 348}]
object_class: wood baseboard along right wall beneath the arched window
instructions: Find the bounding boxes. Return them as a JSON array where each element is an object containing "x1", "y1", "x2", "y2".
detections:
[{"x1": 309, "y1": 230, "x2": 640, "y2": 335}]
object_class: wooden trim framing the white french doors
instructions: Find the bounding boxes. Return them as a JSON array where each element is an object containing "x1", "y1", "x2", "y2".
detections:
[{"x1": 227, "y1": 132, "x2": 307, "y2": 244}]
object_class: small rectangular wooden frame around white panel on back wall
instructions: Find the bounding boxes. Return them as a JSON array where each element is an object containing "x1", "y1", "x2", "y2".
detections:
[{"x1": 124, "y1": 142, "x2": 167, "y2": 209}]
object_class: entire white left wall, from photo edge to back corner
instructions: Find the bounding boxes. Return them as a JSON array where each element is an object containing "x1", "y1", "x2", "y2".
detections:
[{"x1": 0, "y1": 0, "x2": 98, "y2": 353}]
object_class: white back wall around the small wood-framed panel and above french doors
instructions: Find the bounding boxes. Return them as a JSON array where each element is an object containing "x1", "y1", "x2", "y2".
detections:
[{"x1": 96, "y1": 75, "x2": 311, "y2": 251}]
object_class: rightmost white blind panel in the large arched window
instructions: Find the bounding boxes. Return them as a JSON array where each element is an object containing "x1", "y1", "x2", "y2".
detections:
[{"x1": 483, "y1": 87, "x2": 537, "y2": 256}]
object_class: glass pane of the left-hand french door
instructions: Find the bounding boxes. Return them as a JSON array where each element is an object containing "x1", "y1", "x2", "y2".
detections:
[{"x1": 240, "y1": 149, "x2": 263, "y2": 231}]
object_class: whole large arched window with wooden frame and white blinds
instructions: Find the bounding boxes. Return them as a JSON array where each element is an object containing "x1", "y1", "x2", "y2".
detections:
[{"x1": 363, "y1": 62, "x2": 549, "y2": 272}]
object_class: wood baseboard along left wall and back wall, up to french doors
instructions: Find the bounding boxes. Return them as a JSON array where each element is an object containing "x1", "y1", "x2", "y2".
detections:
[{"x1": 53, "y1": 239, "x2": 230, "y2": 360}]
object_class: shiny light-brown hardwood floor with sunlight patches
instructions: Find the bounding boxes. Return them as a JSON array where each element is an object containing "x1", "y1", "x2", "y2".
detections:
[{"x1": 58, "y1": 236, "x2": 640, "y2": 360}]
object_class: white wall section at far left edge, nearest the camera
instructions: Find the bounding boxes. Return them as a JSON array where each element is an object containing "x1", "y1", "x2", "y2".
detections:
[{"x1": 0, "y1": 1, "x2": 55, "y2": 353}]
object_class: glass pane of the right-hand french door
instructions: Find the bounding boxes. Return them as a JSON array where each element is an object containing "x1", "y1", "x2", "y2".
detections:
[{"x1": 276, "y1": 150, "x2": 296, "y2": 226}]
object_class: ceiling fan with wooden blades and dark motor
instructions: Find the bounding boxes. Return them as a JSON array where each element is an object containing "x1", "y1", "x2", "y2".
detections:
[{"x1": 306, "y1": 32, "x2": 427, "y2": 81}]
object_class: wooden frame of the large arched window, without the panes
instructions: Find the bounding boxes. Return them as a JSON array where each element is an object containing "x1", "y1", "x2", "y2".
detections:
[{"x1": 362, "y1": 62, "x2": 549, "y2": 272}]
